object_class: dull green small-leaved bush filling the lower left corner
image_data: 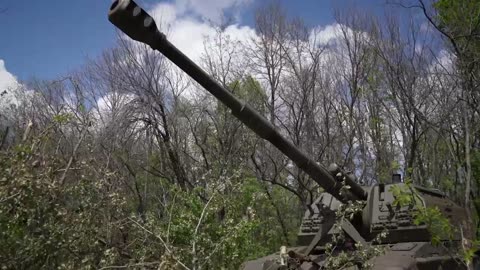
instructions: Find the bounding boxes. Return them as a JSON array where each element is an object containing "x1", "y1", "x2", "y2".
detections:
[{"x1": 0, "y1": 142, "x2": 129, "y2": 269}]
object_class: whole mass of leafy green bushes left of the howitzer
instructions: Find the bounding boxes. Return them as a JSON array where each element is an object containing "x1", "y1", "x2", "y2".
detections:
[{"x1": 0, "y1": 128, "x2": 286, "y2": 269}]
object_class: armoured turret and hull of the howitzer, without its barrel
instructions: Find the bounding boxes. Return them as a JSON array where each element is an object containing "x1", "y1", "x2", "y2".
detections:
[{"x1": 242, "y1": 184, "x2": 471, "y2": 270}]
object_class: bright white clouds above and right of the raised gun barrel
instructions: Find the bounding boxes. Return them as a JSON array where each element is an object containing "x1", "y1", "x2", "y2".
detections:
[{"x1": 117, "y1": 0, "x2": 353, "y2": 104}]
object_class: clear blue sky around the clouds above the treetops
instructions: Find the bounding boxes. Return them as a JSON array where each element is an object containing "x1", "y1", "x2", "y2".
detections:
[{"x1": 0, "y1": 0, "x2": 384, "y2": 80}]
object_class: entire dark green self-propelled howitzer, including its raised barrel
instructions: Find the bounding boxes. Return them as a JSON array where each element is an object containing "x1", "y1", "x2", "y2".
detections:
[{"x1": 109, "y1": 0, "x2": 469, "y2": 270}]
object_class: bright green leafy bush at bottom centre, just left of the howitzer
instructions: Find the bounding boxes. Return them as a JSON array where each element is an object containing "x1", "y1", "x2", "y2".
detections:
[{"x1": 136, "y1": 180, "x2": 268, "y2": 269}]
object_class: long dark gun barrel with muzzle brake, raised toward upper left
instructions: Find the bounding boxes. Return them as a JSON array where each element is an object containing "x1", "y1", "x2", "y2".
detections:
[{"x1": 108, "y1": 0, "x2": 367, "y2": 202}]
